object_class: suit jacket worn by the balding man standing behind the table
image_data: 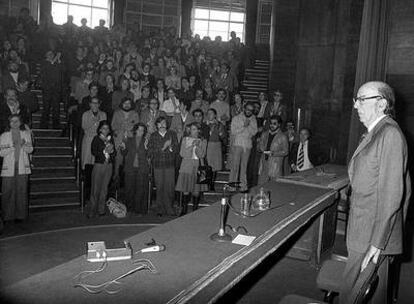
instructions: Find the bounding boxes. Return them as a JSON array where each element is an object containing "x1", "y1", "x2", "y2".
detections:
[{"x1": 347, "y1": 116, "x2": 411, "y2": 254}]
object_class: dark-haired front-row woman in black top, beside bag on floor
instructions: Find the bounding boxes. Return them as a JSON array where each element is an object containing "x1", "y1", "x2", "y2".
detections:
[{"x1": 87, "y1": 120, "x2": 116, "y2": 218}]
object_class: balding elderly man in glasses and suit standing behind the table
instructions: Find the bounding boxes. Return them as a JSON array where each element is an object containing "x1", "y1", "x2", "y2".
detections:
[{"x1": 340, "y1": 81, "x2": 411, "y2": 303}]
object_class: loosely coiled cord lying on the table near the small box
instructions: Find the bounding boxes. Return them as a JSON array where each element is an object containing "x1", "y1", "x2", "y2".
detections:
[{"x1": 73, "y1": 259, "x2": 157, "y2": 295}]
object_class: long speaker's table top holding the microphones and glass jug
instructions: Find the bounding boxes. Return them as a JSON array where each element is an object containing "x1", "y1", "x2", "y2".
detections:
[{"x1": 1, "y1": 182, "x2": 335, "y2": 303}]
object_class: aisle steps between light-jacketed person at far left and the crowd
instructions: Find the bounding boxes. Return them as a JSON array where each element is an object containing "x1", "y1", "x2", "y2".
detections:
[{"x1": 29, "y1": 79, "x2": 80, "y2": 211}]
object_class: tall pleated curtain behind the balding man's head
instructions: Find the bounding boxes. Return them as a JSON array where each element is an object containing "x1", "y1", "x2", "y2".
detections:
[{"x1": 348, "y1": 0, "x2": 390, "y2": 161}]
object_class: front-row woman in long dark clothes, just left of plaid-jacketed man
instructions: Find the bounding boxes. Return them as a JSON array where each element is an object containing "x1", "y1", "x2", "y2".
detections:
[{"x1": 123, "y1": 123, "x2": 150, "y2": 215}]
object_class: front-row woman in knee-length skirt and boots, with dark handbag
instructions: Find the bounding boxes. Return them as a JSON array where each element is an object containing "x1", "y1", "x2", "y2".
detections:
[{"x1": 175, "y1": 122, "x2": 208, "y2": 215}]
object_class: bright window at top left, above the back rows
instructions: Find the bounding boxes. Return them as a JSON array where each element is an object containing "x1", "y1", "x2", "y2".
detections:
[{"x1": 52, "y1": 0, "x2": 111, "y2": 28}]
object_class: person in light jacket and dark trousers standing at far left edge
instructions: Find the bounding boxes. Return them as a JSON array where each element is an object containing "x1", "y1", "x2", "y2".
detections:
[{"x1": 0, "y1": 114, "x2": 33, "y2": 223}]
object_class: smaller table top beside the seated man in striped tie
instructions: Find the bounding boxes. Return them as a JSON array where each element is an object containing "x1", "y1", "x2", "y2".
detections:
[{"x1": 277, "y1": 164, "x2": 349, "y2": 190}]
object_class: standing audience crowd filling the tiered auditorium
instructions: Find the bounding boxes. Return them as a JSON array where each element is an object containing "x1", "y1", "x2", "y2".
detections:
[{"x1": 0, "y1": 9, "x2": 326, "y2": 224}]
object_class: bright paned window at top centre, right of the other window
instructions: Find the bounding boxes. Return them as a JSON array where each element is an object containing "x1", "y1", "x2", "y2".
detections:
[{"x1": 192, "y1": 0, "x2": 246, "y2": 42}]
